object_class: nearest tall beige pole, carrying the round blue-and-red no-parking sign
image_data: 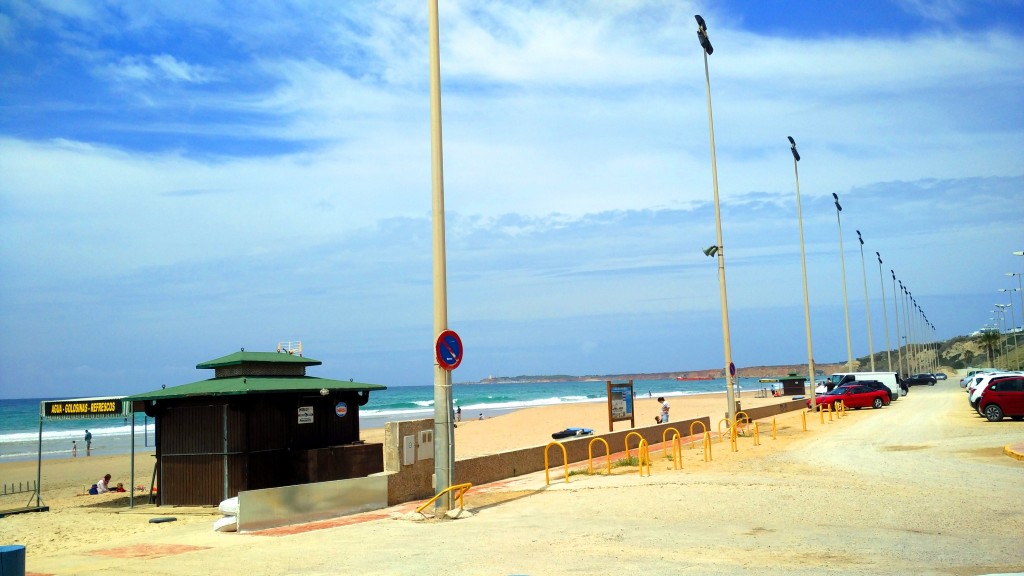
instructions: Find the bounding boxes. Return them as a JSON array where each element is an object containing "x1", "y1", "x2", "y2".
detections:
[{"x1": 429, "y1": 0, "x2": 461, "y2": 512}]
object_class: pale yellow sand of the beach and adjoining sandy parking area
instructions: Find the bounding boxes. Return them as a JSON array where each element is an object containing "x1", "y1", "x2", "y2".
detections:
[{"x1": 0, "y1": 378, "x2": 1024, "y2": 575}]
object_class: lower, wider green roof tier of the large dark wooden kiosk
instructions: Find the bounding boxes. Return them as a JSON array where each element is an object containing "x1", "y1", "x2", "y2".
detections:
[{"x1": 124, "y1": 375, "x2": 387, "y2": 402}]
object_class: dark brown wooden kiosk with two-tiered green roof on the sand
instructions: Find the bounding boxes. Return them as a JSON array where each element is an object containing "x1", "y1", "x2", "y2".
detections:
[{"x1": 125, "y1": 348, "x2": 386, "y2": 505}]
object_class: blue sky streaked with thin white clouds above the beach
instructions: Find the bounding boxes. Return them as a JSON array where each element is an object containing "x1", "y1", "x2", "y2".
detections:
[{"x1": 0, "y1": 0, "x2": 1024, "y2": 398}]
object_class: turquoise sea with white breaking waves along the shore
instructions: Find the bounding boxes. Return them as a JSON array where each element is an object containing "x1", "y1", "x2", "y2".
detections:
[{"x1": 0, "y1": 378, "x2": 760, "y2": 463}]
